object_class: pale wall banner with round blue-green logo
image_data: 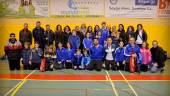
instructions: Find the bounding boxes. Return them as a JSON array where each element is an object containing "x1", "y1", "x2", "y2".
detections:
[{"x1": 50, "y1": 0, "x2": 104, "y2": 16}]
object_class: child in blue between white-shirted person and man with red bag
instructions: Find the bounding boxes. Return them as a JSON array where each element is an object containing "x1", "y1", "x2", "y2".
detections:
[{"x1": 115, "y1": 41, "x2": 125, "y2": 70}]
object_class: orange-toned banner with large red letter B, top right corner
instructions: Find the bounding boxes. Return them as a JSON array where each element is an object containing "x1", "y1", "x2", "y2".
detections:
[{"x1": 158, "y1": 0, "x2": 170, "y2": 18}]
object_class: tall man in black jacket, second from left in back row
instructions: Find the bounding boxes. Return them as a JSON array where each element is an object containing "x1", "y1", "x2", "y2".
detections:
[{"x1": 33, "y1": 21, "x2": 45, "y2": 49}]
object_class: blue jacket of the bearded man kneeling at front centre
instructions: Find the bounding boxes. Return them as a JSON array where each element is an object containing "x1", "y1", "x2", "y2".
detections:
[{"x1": 90, "y1": 45, "x2": 104, "y2": 60}]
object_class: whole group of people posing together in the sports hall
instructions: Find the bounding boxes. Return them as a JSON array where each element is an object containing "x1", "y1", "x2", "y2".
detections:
[{"x1": 4, "y1": 21, "x2": 166, "y2": 73}]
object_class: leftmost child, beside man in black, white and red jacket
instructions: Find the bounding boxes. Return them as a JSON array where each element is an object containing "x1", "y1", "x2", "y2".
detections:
[{"x1": 21, "y1": 42, "x2": 31, "y2": 70}]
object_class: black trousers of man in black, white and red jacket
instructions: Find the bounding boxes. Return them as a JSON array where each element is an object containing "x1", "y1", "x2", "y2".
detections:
[{"x1": 8, "y1": 59, "x2": 20, "y2": 71}]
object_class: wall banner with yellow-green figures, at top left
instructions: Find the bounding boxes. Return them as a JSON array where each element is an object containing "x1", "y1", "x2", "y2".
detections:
[{"x1": 0, "y1": 0, "x2": 49, "y2": 17}]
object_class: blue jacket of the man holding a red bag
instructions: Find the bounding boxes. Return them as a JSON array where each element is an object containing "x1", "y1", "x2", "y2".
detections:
[{"x1": 124, "y1": 44, "x2": 142, "y2": 64}]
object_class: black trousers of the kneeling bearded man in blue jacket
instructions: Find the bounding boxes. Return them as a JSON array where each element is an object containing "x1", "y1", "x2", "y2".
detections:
[{"x1": 88, "y1": 60, "x2": 103, "y2": 71}]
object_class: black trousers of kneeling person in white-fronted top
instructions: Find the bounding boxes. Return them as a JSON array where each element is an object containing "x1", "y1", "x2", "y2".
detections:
[{"x1": 105, "y1": 60, "x2": 117, "y2": 70}]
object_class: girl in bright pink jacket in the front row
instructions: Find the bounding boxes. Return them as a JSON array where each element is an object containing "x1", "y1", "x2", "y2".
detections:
[{"x1": 140, "y1": 42, "x2": 152, "y2": 71}]
